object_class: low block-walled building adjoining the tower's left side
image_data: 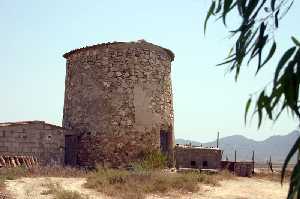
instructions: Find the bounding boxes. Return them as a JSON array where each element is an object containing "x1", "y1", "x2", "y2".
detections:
[{"x1": 0, "y1": 122, "x2": 65, "y2": 165}]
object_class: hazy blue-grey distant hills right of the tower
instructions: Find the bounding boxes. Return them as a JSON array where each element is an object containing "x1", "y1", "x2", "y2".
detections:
[{"x1": 176, "y1": 131, "x2": 300, "y2": 163}]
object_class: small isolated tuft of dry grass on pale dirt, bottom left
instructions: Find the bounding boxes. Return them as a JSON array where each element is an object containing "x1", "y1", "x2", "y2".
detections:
[{"x1": 41, "y1": 183, "x2": 88, "y2": 199}]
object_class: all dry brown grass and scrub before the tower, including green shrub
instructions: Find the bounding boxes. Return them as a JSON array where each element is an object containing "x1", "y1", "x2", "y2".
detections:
[{"x1": 0, "y1": 153, "x2": 233, "y2": 199}]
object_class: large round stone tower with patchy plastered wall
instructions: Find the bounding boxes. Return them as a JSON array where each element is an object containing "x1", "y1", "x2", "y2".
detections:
[{"x1": 63, "y1": 40, "x2": 174, "y2": 167}]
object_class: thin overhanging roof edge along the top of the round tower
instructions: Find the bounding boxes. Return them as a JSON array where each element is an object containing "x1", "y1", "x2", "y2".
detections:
[{"x1": 63, "y1": 40, "x2": 175, "y2": 61}]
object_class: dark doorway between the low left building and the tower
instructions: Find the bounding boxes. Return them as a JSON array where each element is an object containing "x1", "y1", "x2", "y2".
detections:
[{"x1": 65, "y1": 135, "x2": 78, "y2": 166}]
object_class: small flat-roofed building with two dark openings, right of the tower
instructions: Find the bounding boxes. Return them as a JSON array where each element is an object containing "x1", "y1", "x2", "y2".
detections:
[{"x1": 175, "y1": 145, "x2": 222, "y2": 169}]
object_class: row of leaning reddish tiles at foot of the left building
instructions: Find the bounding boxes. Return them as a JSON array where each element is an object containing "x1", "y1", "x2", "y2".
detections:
[{"x1": 0, "y1": 156, "x2": 38, "y2": 168}]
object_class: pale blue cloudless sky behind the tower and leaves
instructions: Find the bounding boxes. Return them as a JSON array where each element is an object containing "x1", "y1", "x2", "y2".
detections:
[{"x1": 0, "y1": 0, "x2": 300, "y2": 142}]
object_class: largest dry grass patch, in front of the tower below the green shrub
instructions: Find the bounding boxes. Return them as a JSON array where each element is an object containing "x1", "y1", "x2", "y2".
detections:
[{"x1": 85, "y1": 168, "x2": 232, "y2": 199}]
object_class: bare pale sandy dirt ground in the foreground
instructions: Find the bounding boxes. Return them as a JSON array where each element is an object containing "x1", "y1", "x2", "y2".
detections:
[{"x1": 6, "y1": 178, "x2": 288, "y2": 199}]
